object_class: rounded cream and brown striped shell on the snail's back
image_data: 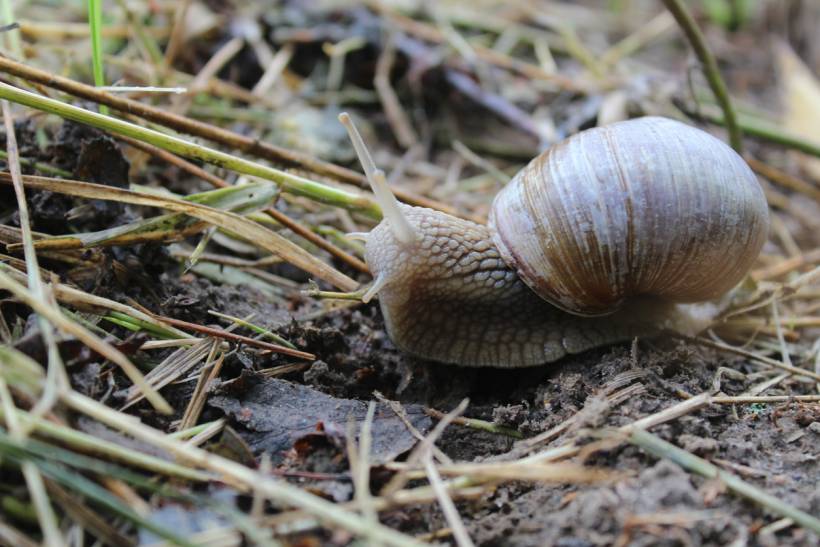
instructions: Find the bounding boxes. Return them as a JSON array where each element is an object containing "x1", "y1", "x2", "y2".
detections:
[{"x1": 489, "y1": 117, "x2": 769, "y2": 316}]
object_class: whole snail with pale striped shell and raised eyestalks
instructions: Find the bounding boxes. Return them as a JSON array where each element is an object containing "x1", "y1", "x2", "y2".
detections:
[{"x1": 339, "y1": 114, "x2": 769, "y2": 368}]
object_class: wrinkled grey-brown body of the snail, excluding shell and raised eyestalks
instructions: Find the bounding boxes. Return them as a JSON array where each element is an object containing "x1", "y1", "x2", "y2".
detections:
[{"x1": 365, "y1": 205, "x2": 709, "y2": 368}]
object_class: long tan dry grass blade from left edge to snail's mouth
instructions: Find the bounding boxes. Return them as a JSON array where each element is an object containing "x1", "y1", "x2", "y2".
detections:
[{"x1": 0, "y1": 173, "x2": 359, "y2": 291}]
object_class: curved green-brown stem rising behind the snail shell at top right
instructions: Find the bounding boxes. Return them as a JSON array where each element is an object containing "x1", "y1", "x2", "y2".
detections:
[{"x1": 663, "y1": 0, "x2": 743, "y2": 155}]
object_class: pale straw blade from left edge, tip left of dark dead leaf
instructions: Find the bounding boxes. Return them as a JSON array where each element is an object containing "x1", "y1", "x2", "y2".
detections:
[{"x1": 0, "y1": 264, "x2": 173, "y2": 414}]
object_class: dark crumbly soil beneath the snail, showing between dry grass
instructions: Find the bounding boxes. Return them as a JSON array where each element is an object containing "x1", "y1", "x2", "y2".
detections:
[{"x1": 0, "y1": 2, "x2": 820, "y2": 547}]
